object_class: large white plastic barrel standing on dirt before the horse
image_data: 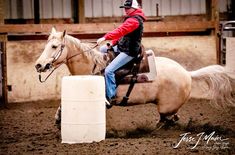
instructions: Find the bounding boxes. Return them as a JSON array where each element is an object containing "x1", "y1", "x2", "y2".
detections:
[{"x1": 61, "y1": 76, "x2": 106, "y2": 144}]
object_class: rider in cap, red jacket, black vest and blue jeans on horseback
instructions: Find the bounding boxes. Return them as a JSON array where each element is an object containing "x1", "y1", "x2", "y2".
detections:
[{"x1": 97, "y1": 0, "x2": 146, "y2": 101}]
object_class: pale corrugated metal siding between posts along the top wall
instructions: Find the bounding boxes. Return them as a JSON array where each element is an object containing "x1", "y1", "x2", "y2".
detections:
[{"x1": 5, "y1": 0, "x2": 231, "y2": 19}]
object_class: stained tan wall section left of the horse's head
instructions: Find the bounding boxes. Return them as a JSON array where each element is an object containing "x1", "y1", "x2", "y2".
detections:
[{"x1": 6, "y1": 40, "x2": 68, "y2": 102}]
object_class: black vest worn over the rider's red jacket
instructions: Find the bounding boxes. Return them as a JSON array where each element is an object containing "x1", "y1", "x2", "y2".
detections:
[{"x1": 117, "y1": 15, "x2": 144, "y2": 57}]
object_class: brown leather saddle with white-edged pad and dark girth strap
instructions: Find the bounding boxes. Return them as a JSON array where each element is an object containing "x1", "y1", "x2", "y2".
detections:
[{"x1": 106, "y1": 46, "x2": 157, "y2": 106}]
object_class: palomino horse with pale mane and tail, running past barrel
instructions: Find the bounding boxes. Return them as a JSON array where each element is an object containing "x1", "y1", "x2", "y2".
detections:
[{"x1": 35, "y1": 28, "x2": 235, "y2": 124}]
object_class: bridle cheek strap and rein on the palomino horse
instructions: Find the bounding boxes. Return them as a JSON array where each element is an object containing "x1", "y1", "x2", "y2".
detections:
[{"x1": 38, "y1": 44, "x2": 98, "y2": 83}]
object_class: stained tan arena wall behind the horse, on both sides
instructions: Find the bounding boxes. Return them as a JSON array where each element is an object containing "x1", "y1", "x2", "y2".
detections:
[{"x1": 7, "y1": 36, "x2": 216, "y2": 102}]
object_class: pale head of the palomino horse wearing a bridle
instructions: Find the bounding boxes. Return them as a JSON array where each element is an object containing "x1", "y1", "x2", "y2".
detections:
[{"x1": 35, "y1": 28, "x2": 67, "y2": 72}]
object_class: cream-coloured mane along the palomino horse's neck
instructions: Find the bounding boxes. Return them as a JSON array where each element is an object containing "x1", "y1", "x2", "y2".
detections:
[{"x1": 65, "y1": 35, "x2": 107, "y2": 71}]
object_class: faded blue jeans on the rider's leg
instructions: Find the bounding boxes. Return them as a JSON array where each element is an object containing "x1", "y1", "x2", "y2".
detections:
[{"x1": 100, "y1": 46, "x2": 133, "y2": 99}]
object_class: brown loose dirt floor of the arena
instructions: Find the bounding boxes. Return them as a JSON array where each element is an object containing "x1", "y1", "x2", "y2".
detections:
[{"x1": 0, "y1": 99, "x2": 235, "y2": 155}]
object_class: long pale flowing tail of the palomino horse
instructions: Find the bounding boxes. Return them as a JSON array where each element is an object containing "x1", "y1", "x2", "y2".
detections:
[{"x1": 190, "y1": 65, "x2": 235, "y2": 108}]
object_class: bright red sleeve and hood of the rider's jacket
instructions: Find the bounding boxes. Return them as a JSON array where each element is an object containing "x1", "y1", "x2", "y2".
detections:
[{"x1": 104, "y1": 9, "x2": 146, "y2": 45}]
